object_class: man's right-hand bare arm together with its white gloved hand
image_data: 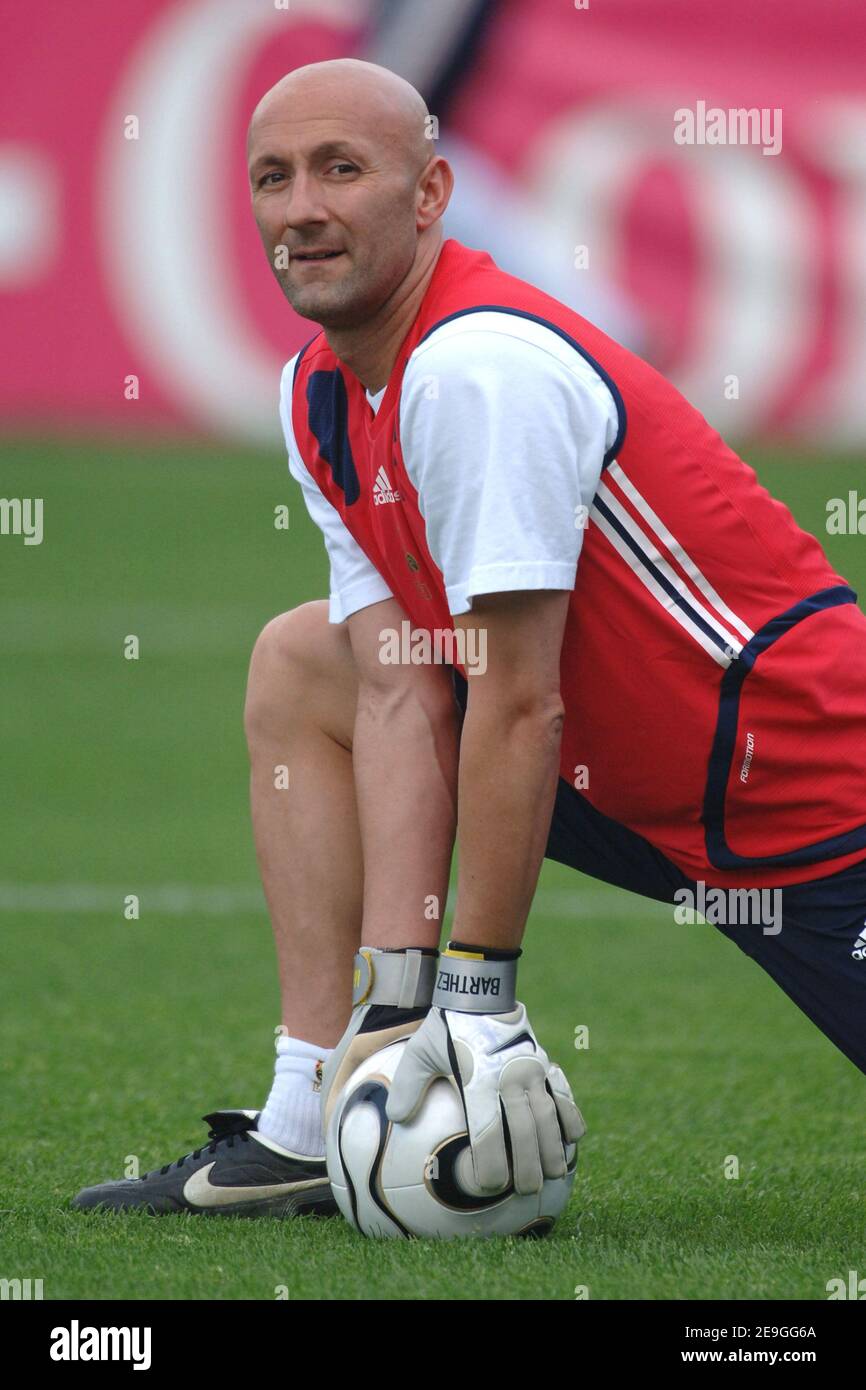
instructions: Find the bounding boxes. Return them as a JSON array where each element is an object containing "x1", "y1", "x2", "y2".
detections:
[{"x1": 385, "y1": 591, "x2": 587, "y2": 1193}]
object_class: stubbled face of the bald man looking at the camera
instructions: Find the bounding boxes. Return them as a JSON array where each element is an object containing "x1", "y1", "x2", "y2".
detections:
[{"x1": 249, "y1": 96, "x2": 418, "y2": 328}]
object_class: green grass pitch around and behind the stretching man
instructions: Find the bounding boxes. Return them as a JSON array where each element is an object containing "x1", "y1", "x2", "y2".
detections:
[{"x1": 0, "y1": 441, "x2": 866, "y2": 1300}]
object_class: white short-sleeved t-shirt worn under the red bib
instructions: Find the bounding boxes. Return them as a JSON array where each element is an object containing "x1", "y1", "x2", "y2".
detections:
[{"x1": 279, "y1": 310, "x2": 619, "y2": 623}]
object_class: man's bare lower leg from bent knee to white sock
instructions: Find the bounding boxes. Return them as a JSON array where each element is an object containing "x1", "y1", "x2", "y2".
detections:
[{"x1": 245, "y1": 599, "x2": 363, "y2": 1048}]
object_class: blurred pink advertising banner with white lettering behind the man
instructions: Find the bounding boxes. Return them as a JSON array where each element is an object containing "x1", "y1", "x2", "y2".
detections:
[{"x1": 0, "y1": 0, "x2": 866, "y2": 446}]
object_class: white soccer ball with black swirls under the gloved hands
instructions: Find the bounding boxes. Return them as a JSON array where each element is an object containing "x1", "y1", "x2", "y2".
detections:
[{"x1": 327, "y1": 1038, "x2": 577, "y2": 1238}]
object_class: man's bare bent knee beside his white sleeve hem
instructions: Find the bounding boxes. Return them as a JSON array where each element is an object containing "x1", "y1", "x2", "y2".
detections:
[{"x1": 243, "y1": 599, "x2": 354, "y2": 739}]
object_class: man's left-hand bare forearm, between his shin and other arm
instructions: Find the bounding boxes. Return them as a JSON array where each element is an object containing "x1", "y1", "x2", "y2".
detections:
[{"x1": 353, "y1": 669, "x2": 459, "y2": 947}]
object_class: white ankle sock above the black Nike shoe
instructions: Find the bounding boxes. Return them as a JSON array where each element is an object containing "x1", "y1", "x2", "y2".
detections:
[{"x1": 257, "y1": 1034, "x2": 334, "y2": 1158}]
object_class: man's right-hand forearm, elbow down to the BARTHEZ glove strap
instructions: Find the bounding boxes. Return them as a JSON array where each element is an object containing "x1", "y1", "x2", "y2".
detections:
[{"x1": 452, "y1": 700, "x2": 563, "y2": 949}]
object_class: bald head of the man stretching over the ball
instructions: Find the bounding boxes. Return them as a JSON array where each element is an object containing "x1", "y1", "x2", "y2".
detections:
[{"x1": 247, "y1": 58, "x2": 453, "y2": 329}]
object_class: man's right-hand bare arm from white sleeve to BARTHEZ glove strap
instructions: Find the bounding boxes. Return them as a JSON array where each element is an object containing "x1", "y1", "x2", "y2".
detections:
[{"x1": 450, "y1": 589, "x2": 571, "y2": 949}]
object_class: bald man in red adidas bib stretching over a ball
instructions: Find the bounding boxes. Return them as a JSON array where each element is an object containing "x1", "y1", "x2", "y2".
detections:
[{"x1": 76, "y1": 60, "x2": 866, "y2": 1215}]
